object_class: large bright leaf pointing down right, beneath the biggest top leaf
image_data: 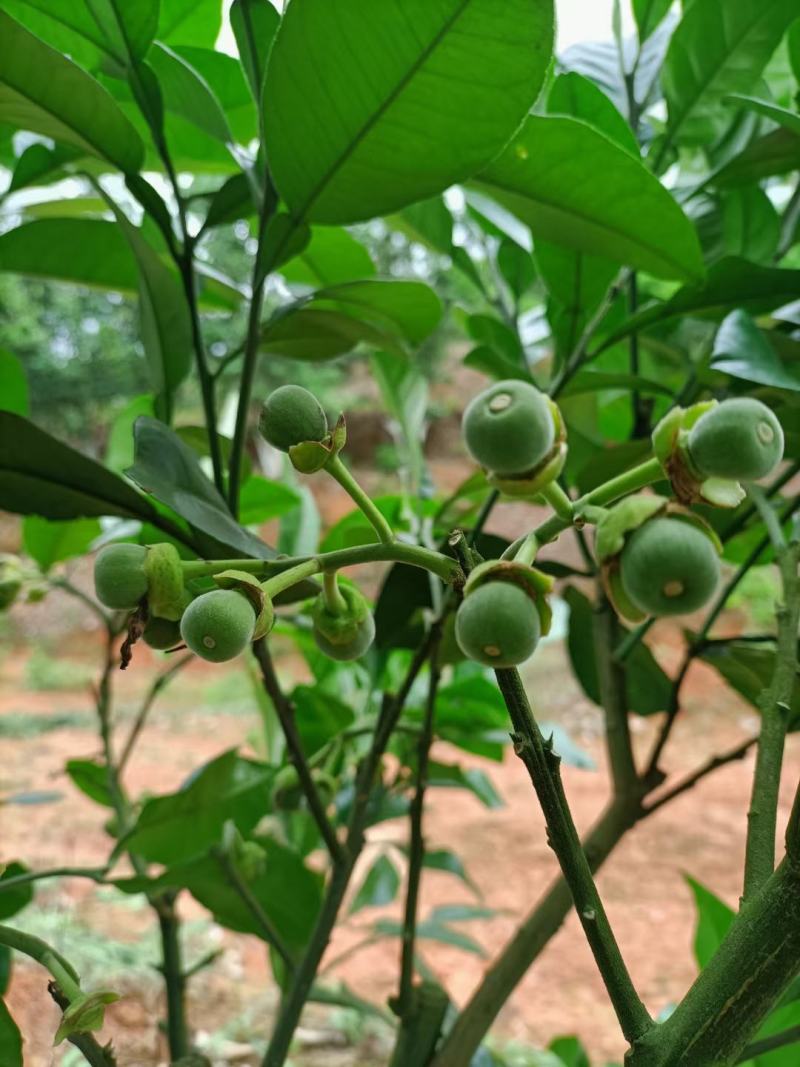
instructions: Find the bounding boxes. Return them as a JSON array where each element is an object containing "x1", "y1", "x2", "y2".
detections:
[{"x1": 476, "y1": 115, "x2": 704, "y2": 280}]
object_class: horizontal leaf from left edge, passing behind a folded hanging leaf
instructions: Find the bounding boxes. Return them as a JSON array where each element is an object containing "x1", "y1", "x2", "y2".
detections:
[{"x1": 0, "y1": 219, "x2": 242, "y2": 310}]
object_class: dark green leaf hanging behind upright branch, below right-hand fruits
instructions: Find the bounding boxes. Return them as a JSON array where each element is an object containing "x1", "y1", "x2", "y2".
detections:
[{"x1": 564, "y1": 586, "x2": 672, "y2": 715}]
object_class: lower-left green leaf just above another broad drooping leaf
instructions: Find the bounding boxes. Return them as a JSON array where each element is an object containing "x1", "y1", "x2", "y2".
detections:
[{"x1": 124, "y1": 749, "x2": 274, "y2": 864}]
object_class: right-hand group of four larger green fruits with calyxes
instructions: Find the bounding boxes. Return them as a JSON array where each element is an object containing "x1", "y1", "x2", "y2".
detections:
[{"x1": 455, "y1": 381, "x2": 784, "y2": 668}]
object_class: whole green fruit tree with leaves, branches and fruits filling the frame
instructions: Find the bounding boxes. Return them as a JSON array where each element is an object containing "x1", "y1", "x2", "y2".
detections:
[{"x1": 0, "y1": 0, "x2": 800, "y2": 1067}]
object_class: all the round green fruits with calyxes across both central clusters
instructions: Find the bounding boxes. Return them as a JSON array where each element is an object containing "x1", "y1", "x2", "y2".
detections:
[{"x1": 95, "y1": 381, "x2": 783, "y2": 668}]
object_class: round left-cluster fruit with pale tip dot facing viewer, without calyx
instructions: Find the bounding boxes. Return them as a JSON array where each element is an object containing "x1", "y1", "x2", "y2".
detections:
[{"x1": 180, "y1": 589, "x2": 256, "y2": 664}]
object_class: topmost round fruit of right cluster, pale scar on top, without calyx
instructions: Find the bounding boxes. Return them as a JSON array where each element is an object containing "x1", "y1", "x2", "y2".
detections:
[{"x1": 462, "y1": 381, "x2": 556, "y2": 475}]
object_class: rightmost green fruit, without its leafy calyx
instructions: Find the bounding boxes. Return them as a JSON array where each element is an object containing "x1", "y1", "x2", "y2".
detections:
[{"x1": 687, "y1": 397, "x2": 784, "y2": 481}]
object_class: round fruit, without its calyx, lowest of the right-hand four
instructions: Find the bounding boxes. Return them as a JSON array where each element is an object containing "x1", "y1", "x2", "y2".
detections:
[{"x1": 455, "y1": 582, "x2": 542, "y2": 668}]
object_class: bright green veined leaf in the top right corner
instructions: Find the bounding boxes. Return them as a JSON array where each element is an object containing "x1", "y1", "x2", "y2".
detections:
[{"x1": 661, "y1": 0, "x2": 797, "y2": 144}]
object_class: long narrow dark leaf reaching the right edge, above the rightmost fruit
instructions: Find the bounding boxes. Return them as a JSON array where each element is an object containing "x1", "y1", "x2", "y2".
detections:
[{"x1": 603, "y1": 257, "x2": 800, "y2": 349}]
